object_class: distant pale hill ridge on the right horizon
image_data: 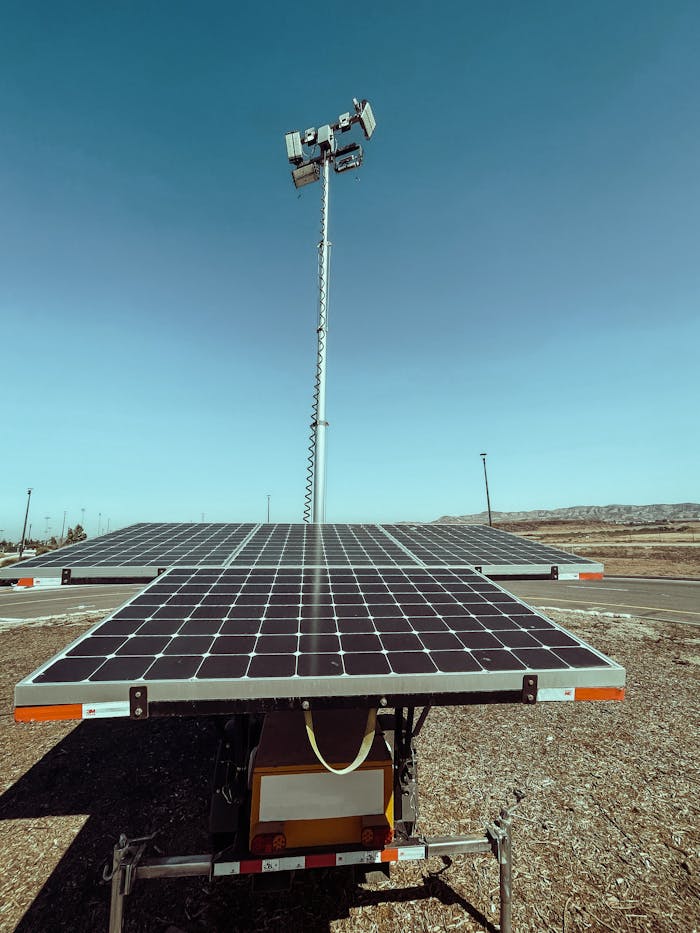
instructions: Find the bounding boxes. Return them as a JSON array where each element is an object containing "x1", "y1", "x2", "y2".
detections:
[{"x1": 436, "y1": 502, "x2": 700, "y2": 525}]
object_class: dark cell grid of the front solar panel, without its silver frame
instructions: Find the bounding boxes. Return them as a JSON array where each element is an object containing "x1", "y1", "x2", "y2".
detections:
[{"x1": 29, "y1": 567, "x2": 611, "y2": 695}]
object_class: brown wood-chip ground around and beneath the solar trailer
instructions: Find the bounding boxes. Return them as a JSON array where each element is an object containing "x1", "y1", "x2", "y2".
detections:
[{"x1": 0, "y1": 611, "x2": 700, "y2": 933}]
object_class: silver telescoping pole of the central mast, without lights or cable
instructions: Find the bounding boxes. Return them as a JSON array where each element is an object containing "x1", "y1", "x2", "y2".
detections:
[{"x1": 311, "y1": 156, "x2": 331, "y2": 525}]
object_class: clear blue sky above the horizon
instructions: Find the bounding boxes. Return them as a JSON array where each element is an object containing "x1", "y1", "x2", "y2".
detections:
[{"x1": 0, "y1": 0, "x2": 700, "y2": 536}]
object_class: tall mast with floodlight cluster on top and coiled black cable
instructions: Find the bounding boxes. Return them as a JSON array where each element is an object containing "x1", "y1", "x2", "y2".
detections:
[{"x1": 284, "y1": 98, "x2": 377, "y2": 524}]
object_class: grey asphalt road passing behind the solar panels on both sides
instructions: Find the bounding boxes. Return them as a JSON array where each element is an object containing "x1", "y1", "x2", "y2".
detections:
[{"x1": 0, "y1": 577, "x2": 700, "y2": 625}]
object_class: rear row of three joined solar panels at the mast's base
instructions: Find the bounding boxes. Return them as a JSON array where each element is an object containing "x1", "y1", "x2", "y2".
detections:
[{"x1": 0, "y1": 522, "x2": 603, "y2": 585}]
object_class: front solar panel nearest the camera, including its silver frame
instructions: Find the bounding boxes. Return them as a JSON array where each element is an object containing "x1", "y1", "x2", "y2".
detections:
[{"x1": 16, "y1": 566, "x2": 624, "y2": 706}]
